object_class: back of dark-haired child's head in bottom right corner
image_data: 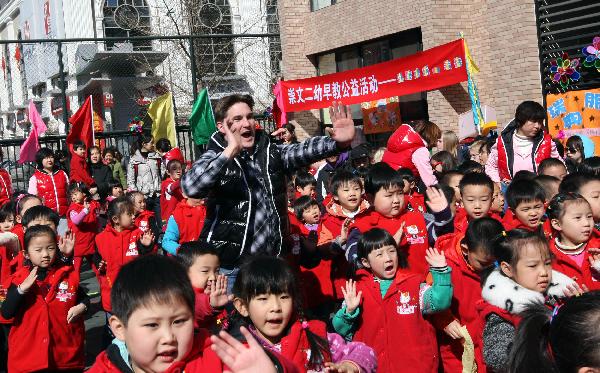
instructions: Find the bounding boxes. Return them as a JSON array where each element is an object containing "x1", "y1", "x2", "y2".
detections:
[{"x1": 506, "y1": 291, "x2": 600, "y2": 373}]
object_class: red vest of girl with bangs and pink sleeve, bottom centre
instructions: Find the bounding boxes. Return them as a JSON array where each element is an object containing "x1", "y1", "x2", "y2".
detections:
[{"x1": 280, "y1": 320, "x2": 331, "y2": 372}]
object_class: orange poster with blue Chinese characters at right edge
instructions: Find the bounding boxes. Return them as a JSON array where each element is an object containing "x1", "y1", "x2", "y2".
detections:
[{"x1": 546, "y1": 89, "x2": 600, "y2": 155}]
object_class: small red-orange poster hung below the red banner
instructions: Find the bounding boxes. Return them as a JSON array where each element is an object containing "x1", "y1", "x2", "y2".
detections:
[{"x1": 361, "y1": 97, "x2": 402, "y2": 135}]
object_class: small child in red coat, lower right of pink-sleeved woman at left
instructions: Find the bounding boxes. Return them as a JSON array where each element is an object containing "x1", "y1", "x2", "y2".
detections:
[{"x1": 67, "y1": 183, "x2": 100, "y2": 271}]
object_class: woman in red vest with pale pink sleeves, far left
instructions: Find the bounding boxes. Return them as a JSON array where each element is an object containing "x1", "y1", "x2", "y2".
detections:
[{"x1": 28, "y1": 148, "x2": 69, "y2": 216}]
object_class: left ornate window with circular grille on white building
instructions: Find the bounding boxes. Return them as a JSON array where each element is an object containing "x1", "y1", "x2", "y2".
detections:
[{"x1": 102, "y1": 0, "x2": 152, "y2": 50}]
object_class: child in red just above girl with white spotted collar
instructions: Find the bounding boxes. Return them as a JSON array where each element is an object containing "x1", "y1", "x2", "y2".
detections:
[{"x1": 502, "y1": 179, "x2": 552, "y2": 237}]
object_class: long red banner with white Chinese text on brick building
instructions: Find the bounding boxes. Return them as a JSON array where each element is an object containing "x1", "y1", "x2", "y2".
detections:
[{"x1": 280, "y1": 39, "x2": 467, "y2": 112}]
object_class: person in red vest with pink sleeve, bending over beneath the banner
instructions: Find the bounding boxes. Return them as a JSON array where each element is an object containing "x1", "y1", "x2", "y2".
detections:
[{"x1": 382, "y1": 120, "x2": 442, "y2": 186}]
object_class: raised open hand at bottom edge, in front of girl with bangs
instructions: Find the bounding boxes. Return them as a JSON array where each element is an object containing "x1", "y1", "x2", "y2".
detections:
[{"x1": 210, "y1": 326, "x2": 277, "y2": 373}]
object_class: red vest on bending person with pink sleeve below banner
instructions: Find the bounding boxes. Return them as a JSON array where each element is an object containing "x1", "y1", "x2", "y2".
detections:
[{"x1": 381, "y1": 124, "x2": 427, "y2": 177}]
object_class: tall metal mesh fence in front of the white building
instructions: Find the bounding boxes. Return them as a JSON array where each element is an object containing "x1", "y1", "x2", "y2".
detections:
[{"x1": 0, "y1": 31, "x2": 281, "y2": 139}]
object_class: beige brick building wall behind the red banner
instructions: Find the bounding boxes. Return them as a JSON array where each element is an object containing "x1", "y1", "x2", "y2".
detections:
[{"x1": 279, "y1": 0, "x2": 542, "y2": 136}]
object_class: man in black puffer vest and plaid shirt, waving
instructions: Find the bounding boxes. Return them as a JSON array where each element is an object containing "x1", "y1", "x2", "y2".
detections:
[{"x1": 181, "y1": 95, "x2": 354, "y2": 285}]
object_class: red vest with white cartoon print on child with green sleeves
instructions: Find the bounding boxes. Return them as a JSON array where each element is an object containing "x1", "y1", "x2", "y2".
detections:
[{"x1": 353, "y1": 269, "x2": 439, "y2": 373}]
